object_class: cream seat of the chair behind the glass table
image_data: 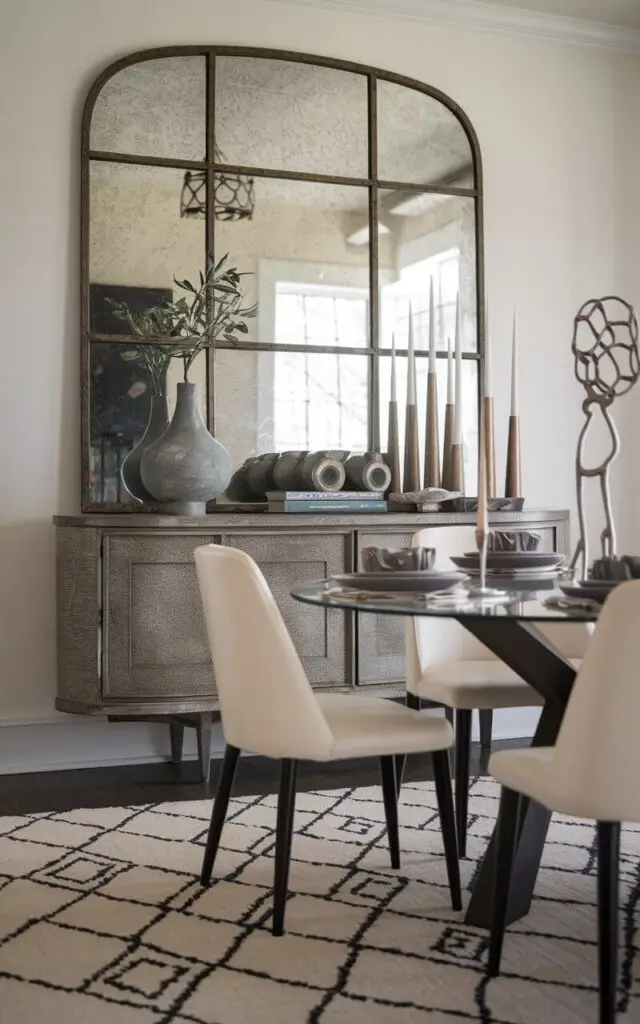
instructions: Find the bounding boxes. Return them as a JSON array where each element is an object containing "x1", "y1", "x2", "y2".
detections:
[{"x1": 415, "y1": 658, "x2": 581, "y2": 710}]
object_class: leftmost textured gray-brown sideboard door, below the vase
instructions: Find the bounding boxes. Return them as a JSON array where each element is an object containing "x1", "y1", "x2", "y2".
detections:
[{"x1": 102, "y1": 531, "x2": 220, "y2": 701}]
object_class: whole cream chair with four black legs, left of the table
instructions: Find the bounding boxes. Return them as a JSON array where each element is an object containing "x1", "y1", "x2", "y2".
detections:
[{"x1": 196, "y1": 545, "x2": 462, "y2": 935}]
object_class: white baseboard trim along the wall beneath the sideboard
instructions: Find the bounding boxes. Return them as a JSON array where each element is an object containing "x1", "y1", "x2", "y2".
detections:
[{"x1": 0, "y1": 708, "x2": 540, "y2": 775}]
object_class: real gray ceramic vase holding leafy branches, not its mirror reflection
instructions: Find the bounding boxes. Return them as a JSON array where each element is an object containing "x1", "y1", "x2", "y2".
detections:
[{"x1": 141, "y1": 383, "x2": 231, "y2": 515}]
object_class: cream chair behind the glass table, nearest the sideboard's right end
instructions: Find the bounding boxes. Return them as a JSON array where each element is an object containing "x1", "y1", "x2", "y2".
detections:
[{"x1": 397, "y1": 526, "x2": 591, "y2": 857}]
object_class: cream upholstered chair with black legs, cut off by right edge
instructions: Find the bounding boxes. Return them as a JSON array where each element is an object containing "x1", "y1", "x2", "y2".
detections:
[{"x1": 488, "y1": 581, "x2": 640, "y2": 1024}]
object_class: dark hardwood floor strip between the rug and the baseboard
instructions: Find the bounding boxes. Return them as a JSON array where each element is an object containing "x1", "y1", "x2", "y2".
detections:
[{"x1": 0, "y1": 740, "x2": 528, "y2": 815}]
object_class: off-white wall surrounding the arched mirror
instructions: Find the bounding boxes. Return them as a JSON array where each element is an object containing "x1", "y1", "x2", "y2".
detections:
[{"x1": 0, "y1": 0, "x2": 640, "y2": 767}]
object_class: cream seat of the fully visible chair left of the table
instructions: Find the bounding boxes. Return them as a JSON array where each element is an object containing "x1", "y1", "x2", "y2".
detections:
[{"x1": 317, "y1": 693, "x2": 454, "y2": 761}]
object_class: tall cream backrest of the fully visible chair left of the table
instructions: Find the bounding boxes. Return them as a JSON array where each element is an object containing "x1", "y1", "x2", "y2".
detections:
[{"x1": 196, "y1": 544, "x2": 333, "y2": 760}]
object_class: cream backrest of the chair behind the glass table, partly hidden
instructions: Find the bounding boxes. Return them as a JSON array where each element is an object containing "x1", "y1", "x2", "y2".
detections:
[{"x1": 406, "y1": 526, "x2": 593, "y2": 687}]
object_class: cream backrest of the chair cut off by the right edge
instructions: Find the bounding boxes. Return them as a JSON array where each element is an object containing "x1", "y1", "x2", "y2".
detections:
[{"x1": 554, "y1": 580, "x2": 640, "y2": 821}]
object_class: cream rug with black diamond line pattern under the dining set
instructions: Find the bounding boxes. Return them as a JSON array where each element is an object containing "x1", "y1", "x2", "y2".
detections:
[{"x1": 0, "y1": 779, "x2": 640, "y2": 1024}]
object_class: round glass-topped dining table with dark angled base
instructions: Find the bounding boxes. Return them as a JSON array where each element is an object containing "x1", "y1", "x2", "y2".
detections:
[{"x1": 291, "y1": 579, "x2": 600, "y2": 928}]
